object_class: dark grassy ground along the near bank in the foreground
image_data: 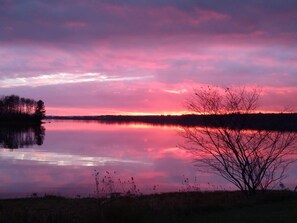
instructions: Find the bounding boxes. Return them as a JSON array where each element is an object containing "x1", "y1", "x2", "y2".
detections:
[{"x1": 0, "y1": 191, "x2": 297, "y2": 223}]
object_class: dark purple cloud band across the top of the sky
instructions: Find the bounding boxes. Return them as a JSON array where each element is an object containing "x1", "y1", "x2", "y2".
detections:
[{"x1": 0, "y1": 0, "x2": 297, "y2": 45}]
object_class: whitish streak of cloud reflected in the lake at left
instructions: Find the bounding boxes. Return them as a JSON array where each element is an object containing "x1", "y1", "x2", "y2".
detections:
[{"x1": 0, "y1": 150, "x2": 151, "y2": 166}]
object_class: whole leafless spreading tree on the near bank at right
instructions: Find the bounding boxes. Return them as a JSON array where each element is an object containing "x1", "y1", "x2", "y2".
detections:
[{"x1": 181, "y1": 88, "x2": 296, "y2": 193}]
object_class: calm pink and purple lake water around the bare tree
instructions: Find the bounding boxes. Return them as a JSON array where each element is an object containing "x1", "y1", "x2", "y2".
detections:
[{"x1": 0, "y1": 121, "x2": 297, "y2": 198}]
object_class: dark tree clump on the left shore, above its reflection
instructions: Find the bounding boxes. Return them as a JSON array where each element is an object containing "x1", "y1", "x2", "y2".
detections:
[{"x1": 0, "y1": 95, "x2": 45, "y2": 122}]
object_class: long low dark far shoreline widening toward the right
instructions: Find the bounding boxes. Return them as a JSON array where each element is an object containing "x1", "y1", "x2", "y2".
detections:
[{"x1": 47, "y1": 113, "x2": 297, "y2": 131}]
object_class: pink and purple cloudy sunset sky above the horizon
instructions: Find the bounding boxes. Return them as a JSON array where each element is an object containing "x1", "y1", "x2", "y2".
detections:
[{"x1": 0, "y1": 0, "x2": 297, "y2": 115}]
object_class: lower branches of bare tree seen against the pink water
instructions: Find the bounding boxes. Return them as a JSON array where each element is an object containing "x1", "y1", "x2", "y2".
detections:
[{"x1": 181, "y1": 127, "x2": 297, "y2": 193}]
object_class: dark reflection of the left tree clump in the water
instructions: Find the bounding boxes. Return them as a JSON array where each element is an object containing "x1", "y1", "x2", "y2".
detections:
[{"x1": 0, "y1": 125, "x2": 45, "y2": 149}]
